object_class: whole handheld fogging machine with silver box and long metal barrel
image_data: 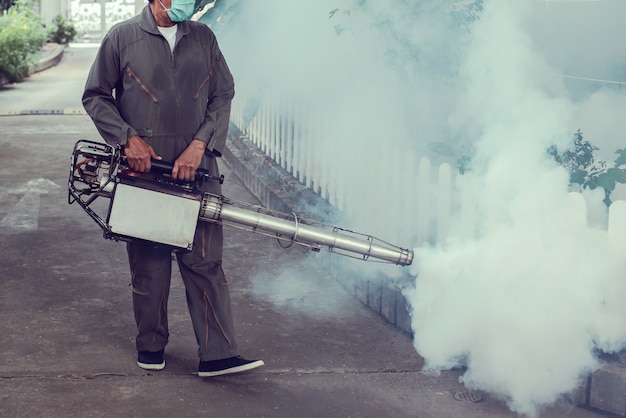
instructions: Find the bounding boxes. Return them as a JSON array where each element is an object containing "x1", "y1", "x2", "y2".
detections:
[{"x1": 68, "y1": 140, "x2": 413, "y2": 266}]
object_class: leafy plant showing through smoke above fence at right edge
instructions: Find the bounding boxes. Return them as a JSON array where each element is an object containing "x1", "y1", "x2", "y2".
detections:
[{"x1": 548, "y1": 129, "x2": 626, "y2": 206}]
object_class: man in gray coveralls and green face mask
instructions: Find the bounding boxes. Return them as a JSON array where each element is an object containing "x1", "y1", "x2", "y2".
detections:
[{"x1": 83, "y1": 0, "x2": 263, "y2": 377}]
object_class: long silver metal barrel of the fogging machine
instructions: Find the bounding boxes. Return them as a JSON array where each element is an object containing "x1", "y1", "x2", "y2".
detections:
[{"x1": 199, "y1": 193, "x2": 413, "y2": 266}]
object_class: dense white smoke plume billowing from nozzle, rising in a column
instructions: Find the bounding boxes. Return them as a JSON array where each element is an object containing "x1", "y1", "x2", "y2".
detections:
[{"x1": 406, "y1": 0, "x2": 626, "y2": 416}]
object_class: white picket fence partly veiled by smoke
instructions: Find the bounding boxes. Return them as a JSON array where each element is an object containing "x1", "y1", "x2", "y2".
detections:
[{"x1": 231, "y1": 89, "x2": 626, "y2": 255}]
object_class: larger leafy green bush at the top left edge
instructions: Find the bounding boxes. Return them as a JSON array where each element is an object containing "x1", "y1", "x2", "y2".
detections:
[{"x1": 0, "y1": 0, "x2": 48, "y2": 81}]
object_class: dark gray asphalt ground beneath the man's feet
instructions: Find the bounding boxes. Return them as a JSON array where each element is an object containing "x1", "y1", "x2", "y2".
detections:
[{"x1": 0, "y1": 47, "x2": 601, "y2": 418}]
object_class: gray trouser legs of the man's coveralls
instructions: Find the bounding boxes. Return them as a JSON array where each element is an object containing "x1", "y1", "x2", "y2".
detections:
[{"x1": 127, "y1": 222, "x2": 238, "y2": 361}]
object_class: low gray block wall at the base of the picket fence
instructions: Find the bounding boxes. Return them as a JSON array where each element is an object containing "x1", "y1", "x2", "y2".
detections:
[{"x1": 224, "y1": 125, "x2": 626, "y2": 417}]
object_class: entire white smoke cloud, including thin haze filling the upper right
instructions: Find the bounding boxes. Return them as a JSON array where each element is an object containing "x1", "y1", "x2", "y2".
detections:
[{"x1": 213, "y1": 0, "x2": 626, "y2": 415}]
